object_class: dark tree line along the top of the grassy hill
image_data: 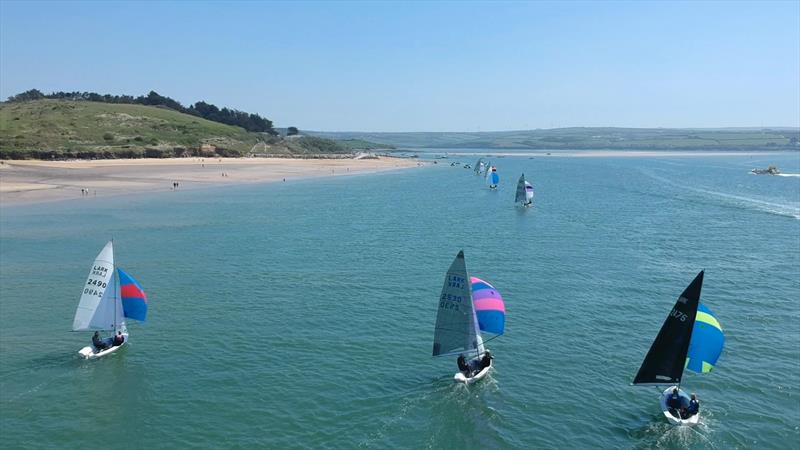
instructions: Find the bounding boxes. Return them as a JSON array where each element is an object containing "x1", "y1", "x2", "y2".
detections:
[{"x1": 8, "y1": 89, "x2": 278, "y2": 135}]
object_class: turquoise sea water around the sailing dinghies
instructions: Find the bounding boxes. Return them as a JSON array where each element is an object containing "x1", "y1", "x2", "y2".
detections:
[{"x1": 0, "y1": 153, "x2": 800, "y2": 449}]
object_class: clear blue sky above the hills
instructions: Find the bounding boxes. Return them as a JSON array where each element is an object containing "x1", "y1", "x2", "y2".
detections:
[{"x1": 0, "y1": 0, "x2": 800, "y2": 131}]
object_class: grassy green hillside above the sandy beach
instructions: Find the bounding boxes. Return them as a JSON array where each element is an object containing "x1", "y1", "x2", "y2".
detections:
[{"x1": 0, "y1": 99, "x2": 349, "y2": 159}]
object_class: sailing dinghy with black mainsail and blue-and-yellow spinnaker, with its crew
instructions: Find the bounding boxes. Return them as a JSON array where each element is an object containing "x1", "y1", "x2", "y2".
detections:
[{"x1": 633, "y1": 271, "x2": 725, "y2": 425}]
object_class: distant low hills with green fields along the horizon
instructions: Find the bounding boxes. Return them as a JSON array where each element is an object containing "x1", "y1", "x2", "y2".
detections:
[{"x1": 306, "y1": 128, "x2": 800, "y2": 150}]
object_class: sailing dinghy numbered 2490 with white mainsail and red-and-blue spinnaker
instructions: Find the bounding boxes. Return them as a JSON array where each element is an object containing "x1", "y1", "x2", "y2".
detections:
[{"x1": 72, "y1": 242, "x2": 147, "y2": 359}]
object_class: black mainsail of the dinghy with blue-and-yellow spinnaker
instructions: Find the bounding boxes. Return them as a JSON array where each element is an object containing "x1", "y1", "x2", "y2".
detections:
[{"x1": 633, "y1": 270, "x2": 703, "y2": 384}]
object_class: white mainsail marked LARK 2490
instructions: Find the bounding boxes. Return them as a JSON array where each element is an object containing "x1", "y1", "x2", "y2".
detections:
[{"x1": 72, "y1": 242, "x2": 123, "y2": 331}]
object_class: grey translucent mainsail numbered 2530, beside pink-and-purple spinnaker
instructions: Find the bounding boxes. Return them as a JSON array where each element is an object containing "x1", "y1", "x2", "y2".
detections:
[{"x1": 433, "y1": 251, "x2": 483, "y2": 356}]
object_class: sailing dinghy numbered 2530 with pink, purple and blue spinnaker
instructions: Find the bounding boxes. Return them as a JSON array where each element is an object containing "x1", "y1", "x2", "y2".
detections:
[{"x1": 433, "y1": 250, "x2": 505, "y2": 384}]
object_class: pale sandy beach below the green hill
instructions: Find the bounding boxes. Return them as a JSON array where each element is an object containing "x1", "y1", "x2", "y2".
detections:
[{"x1": 0, "y1": 157, "x2": 419, "y2": 206}]
